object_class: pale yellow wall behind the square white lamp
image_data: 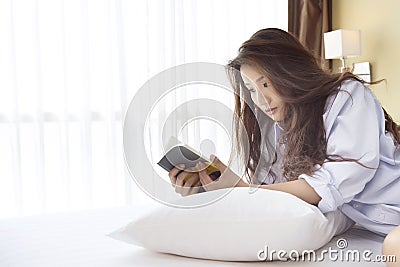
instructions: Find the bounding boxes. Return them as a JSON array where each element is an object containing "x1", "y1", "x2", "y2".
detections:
[{"x1": 332, "y1": 0, "x2": 400, "y2": 122}]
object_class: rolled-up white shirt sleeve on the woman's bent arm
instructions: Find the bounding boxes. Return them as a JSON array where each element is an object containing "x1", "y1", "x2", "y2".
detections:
[{"x1": 299, "y1": 81, "x2": 381, "y2": 213}]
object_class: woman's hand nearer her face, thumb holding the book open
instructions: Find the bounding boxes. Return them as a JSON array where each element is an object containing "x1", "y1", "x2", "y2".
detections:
[{"x1": 199, "y1": 155, "x2": 248, "y2": 191}]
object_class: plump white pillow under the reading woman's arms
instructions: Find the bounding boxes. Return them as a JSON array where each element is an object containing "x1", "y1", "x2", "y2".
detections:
[{"x1": 109, "y1": 187, "x2": 352, "y2": 261}]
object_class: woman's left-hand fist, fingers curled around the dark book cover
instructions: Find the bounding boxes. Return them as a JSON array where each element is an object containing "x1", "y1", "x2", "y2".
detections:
[{"x1": 168, "y1": 165, "x2": 201, "y2": 196}]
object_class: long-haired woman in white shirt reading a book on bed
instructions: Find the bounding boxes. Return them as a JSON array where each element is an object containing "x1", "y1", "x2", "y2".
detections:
[{"x1": 169, "y1": 29, "x2": 400, "y2": 261}]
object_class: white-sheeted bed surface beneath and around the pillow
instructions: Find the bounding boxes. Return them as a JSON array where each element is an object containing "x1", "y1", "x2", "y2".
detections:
[{"x1": 0, "y1": 206, "x2": 385, "y2": 267}]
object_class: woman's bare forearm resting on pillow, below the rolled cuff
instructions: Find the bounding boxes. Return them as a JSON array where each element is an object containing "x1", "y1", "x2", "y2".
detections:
[{"x1": 237, "y1": 179, "x2": 321, "y2": 205}]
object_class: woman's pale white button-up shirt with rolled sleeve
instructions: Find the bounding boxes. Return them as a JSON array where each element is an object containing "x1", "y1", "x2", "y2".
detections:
[{"x1": 258, "y1": 80, "x2": 400, "y2": 235}]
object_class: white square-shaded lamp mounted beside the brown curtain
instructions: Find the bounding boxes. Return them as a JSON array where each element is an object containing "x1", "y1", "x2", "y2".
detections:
[{"x1": 324, "y1": 30, "x2": 361, "y2": 72}]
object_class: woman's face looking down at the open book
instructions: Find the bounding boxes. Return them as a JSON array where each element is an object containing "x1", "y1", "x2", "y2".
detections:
[{"x1": 240, "y1": 64, "x2": 284, "y2": 121}]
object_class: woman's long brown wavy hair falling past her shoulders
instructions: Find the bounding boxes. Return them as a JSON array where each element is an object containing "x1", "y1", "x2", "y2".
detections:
[{"x1": 226, "y1": 28, "x2": 400, "y2": 184}]
